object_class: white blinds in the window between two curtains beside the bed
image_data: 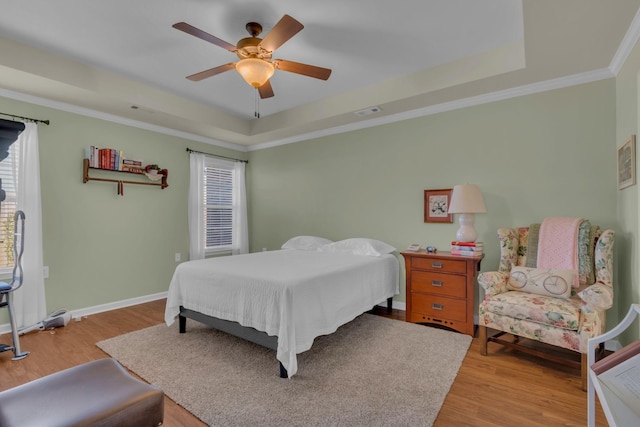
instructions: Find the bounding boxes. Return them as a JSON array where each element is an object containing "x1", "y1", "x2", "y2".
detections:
[{"x1": 204, "y1": 161, "x2": 233, "y2": 252}]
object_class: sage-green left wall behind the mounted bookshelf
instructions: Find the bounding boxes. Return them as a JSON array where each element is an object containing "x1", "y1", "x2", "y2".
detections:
[{"x1": 0, "y1": 97, "x2": 246, "y2": 323}]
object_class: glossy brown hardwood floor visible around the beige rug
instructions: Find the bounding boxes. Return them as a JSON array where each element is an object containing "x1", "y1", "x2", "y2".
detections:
[{"x1": 0, "y1": 300, "x2": 607, "y2": 427}]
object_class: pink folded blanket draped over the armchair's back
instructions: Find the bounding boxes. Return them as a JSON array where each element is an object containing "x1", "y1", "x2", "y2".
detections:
[{"x1": 538, "y1": 218, "x2": 583, "y2": 270}]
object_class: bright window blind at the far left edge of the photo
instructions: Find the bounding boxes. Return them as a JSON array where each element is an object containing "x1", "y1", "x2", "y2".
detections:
[{"x1": 0, "y1": 143, "x2": 20, "y2": 274}]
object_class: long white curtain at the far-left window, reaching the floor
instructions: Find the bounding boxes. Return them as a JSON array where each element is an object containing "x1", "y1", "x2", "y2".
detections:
[{"x1": 14, "y1": 123, "x2": 47, "y2": 327}]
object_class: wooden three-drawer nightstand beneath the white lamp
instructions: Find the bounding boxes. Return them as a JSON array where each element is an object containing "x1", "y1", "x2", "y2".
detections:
[{"x1": 402, "y1": 250, "x2": 484, "y2": 336}]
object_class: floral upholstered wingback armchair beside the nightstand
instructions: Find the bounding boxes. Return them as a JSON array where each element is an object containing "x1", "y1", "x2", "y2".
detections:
[{"x1": 478, "y1": 220, "x2": 615, "y2": 390}]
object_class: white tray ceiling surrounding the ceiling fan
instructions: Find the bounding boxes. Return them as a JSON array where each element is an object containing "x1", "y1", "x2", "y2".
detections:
[{"x1": 0, "y1": 0, "x2": 640, "y2": 147}]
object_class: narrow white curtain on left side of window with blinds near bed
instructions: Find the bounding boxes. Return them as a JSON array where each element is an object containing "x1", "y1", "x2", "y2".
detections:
[{"x1": 188, "y1": 153, "x2": 205, "y2": 260}]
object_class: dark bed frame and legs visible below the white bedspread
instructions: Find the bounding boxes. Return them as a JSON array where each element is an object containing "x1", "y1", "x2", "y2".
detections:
[{"x1": 179, "y1": 297, "x2": 393, "y2": 378}]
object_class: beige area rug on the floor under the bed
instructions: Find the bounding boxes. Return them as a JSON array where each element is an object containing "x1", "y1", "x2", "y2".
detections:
[{"x1": 97, "y1": 314, "x2": 471, "y2": 426}]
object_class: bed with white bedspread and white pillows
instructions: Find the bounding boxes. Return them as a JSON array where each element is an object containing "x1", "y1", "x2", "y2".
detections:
[{"x1": 165, "y1": 236, "x2": 401, "y2": 377}]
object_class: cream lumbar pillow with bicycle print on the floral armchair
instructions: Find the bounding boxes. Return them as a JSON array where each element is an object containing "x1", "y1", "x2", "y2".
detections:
[{"x1": 507, "y1": 267, "x2": 578, "y2": 299}]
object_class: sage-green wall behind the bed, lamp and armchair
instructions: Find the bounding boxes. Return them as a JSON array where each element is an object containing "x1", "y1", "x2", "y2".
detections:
[{"x1": 249, "y1": 79, "x2": 616, "y2": 308}]
